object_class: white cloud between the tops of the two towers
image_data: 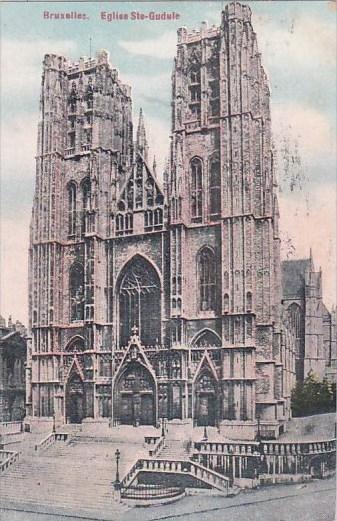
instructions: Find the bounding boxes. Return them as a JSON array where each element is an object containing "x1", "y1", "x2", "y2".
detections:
[{"x1": 118, "y1": 31, "x2": 177, "y2": 60}]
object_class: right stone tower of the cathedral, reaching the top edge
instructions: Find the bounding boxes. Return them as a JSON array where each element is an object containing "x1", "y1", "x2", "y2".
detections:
[{"x1": 169, "y1": 2, "x2": 290, "y2": 431}]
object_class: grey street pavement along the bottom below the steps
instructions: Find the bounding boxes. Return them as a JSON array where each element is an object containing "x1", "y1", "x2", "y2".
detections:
[{"x1": 0, "y1": 478, "x2": 336, "y2": 521}]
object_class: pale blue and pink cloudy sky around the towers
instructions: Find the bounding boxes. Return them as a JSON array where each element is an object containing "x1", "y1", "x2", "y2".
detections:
[{"x1": 0, "y1": 0, "x2": 336, "y2": 324}]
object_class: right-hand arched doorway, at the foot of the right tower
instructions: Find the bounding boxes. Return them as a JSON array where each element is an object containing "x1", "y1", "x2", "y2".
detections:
[{"x1": 194, "y1": 371, "x2": 218, "y2": 425}]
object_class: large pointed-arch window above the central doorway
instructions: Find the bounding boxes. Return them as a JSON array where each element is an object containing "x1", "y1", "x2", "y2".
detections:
[{"x1": 118, "y1": 255, "x2": 161, "y2": 345}]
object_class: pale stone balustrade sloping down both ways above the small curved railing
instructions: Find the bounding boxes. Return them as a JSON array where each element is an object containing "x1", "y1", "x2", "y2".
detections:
[{"x1": 121, "y1": 459, "x2": 230, "y2": 493}]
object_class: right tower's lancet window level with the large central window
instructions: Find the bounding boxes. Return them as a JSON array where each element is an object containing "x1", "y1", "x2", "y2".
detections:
[{"x1": 198, "y1": 247, "x2": 216, "y2": 311}]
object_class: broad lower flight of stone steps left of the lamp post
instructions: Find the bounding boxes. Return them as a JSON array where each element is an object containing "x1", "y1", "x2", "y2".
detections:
[{"x1": 0, "y1": 436, "x2": 130, "y2": 521}]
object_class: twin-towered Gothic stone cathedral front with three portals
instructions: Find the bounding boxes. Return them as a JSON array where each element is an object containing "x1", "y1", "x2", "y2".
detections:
[{"x1": 26, "y1": 2, "x2": 326, "y2": 439}]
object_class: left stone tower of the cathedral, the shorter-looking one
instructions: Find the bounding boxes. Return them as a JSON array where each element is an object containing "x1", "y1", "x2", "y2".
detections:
[{"x1": 28, "y1": 51, "x2": 133, "y2": 420}]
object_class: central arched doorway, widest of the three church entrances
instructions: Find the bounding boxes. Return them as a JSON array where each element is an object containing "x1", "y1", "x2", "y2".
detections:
[{"x1": 114, "y1": 362, "x2": 156, "y2": 426}]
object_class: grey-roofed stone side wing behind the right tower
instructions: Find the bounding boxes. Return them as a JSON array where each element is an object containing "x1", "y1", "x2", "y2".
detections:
[{"x1": 282, "y1": 252, "x2": 337, "y2": 381}]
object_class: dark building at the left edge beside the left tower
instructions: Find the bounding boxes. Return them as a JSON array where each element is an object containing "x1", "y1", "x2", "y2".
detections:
[{"x1": 0, "y1": 316, "x2": 27, "y2": 422}]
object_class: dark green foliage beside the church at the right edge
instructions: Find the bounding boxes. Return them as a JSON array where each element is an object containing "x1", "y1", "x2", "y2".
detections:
[{"x1": 291, "y1": 371, "x2": 336, "y2": 417}]
